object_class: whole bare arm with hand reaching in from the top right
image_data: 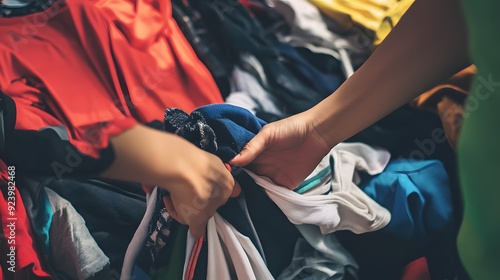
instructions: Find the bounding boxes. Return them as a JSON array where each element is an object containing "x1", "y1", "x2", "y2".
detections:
[{"x1": 231, "y1": 0, "x2": 469, "y2": 188}]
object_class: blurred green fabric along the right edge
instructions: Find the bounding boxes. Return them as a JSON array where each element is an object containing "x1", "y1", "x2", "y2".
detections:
[{"x1": 458, "y1": 0, "x2": 500, "y2": 279}]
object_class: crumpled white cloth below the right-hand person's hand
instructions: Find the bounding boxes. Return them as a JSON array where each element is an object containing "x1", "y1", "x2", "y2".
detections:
[{"x1": 245, "y1": 143, "x2": 391, "y2": 234}]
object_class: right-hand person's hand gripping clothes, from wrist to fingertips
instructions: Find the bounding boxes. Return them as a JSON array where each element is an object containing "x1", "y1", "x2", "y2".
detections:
[{"x1": 230, "y1": 115, "x2": 331, "y2": 189}]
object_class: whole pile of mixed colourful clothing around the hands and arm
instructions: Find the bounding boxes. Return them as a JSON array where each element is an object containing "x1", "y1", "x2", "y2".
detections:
[{"x1": 0, "y1": 0, "x2": 475, "y2": 280}]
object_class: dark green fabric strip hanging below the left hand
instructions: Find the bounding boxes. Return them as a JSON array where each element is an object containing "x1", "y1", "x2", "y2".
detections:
[{"x1": 149, "y1": 225, "x2": 189, "y2": 280}]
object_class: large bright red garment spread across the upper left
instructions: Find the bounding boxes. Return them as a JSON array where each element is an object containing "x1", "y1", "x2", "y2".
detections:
[{"x1": 0, "y1": 0, "x2": 222, "y2": 157}]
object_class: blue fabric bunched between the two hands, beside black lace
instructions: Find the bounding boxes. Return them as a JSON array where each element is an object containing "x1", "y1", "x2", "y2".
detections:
[{"x1": 195, "y1": 104, "x2": 266, "y2": 162}]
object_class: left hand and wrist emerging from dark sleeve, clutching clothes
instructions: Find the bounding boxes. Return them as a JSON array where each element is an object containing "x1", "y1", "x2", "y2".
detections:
[{"x1": 101, "y1": 125, "x2": 235, "y2": 238}]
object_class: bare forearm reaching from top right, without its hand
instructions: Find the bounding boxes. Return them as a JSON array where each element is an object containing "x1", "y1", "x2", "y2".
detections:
[{"x1": 303, "y1": 0, "x2": 469, "y2": 147}]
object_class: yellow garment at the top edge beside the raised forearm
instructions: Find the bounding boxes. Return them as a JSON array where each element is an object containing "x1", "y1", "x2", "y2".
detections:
[{"x1": 309, "y1": 0, "x2": 398, "y2": 32}]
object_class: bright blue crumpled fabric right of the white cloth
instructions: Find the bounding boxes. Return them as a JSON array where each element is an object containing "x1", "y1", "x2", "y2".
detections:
[{"x1": 359, "y1": 159, "x2": 453, "y2": 240}]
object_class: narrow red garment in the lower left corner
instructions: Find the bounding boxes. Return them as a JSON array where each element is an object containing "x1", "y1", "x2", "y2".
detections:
[{"x1": 0, "y1": 161, "x2": 51, "y2": 279}]
